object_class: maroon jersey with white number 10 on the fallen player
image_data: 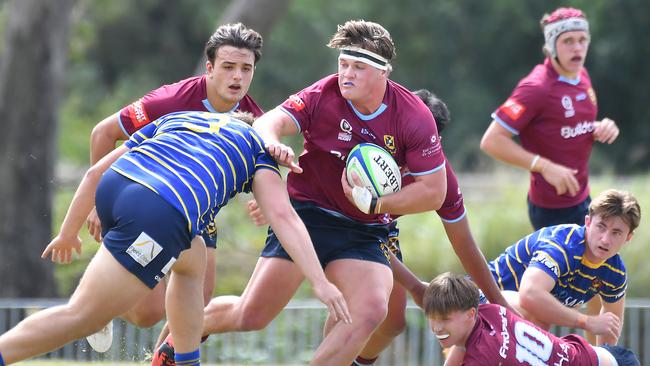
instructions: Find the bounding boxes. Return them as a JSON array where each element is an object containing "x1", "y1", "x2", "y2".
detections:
[{"x1": 463, "y1": 304, "x2": 598, "y2": 366}]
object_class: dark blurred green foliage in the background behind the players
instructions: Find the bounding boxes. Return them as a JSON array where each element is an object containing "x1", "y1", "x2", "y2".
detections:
[{"x1": 57, "y1": 0, "x2": 650, "y2": 174}]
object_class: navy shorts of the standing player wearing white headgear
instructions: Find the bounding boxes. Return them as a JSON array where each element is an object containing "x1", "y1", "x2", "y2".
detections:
[{"x1": 527, "y1": 196, "x2": 591, "y2": 230}]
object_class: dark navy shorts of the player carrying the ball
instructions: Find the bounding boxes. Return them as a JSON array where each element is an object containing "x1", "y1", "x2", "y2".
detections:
[{"x1": 261, "y1": 201, "x2": 390, "y2": 268}]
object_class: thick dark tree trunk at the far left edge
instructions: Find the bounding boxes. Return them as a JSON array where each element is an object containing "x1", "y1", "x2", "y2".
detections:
[{"x1": 0, "y1": 0, "x2": 73, "y2": 297}]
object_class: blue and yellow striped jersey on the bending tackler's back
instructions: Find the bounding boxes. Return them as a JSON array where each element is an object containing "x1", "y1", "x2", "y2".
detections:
[{"x1": 112, "y1": 112, "x2": 280, "y2": 237}]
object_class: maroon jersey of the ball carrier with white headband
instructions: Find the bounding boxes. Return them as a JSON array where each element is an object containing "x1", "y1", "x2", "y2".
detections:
[{"x1": 280, "y1": 74, "x2": 445, "y2": 222}]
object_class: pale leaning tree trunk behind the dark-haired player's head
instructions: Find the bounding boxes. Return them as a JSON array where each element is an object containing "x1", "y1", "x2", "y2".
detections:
[{"x1": 194, "y1": 0, "x2": 290, "y2": 75}]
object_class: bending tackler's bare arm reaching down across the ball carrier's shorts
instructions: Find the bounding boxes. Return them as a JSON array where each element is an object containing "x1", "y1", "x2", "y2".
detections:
[{"x1": 253, "y1": 169, "x2": 351, "y2": 323}]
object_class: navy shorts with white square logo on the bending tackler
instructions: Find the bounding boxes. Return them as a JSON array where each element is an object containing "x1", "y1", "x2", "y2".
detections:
[{"x1": 95, "y1": 169, "x2": 192, "y2": 288}]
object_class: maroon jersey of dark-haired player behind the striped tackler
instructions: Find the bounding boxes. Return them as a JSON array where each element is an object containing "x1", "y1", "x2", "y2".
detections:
[{"x1": 118, "y1": 75, "x2": 264, "y2": 136}]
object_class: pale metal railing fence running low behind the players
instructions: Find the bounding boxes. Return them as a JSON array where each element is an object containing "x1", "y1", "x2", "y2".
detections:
[{"x1": 0, "y1": 299, "x2": 650, "y2": 366}]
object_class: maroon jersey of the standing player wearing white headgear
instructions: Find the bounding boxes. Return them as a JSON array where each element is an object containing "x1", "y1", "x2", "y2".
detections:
[{"x1": 492, "y1": 58, "x2": 598, "y2": 208}]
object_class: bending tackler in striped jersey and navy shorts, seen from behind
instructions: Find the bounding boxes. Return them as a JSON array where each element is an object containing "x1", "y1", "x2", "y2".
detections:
[{"x1": 0, "y1": 112, "x2": 351, "y2": 365}]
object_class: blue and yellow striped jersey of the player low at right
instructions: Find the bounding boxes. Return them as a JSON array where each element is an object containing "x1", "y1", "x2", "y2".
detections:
[{"x1": 489, "y1": 224, "x2": 627, "y2": 307}]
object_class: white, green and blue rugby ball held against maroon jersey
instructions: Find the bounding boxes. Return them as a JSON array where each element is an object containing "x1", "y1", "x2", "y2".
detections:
[{"x1": 345, "y1": 142, "x2": 402, "y2": 198}]
